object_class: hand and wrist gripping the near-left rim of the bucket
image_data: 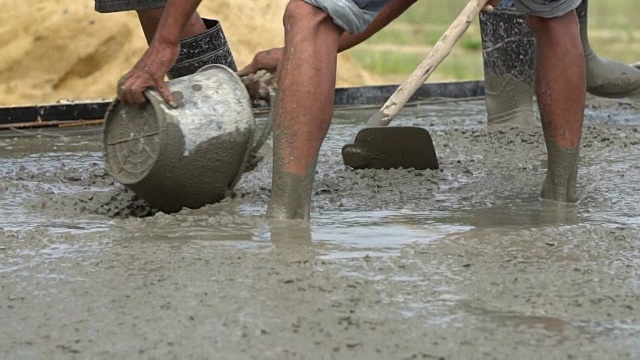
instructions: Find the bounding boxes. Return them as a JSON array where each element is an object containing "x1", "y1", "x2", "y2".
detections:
[{"x1": 118, "y1": 42, "x2": 180, "y2": 108}]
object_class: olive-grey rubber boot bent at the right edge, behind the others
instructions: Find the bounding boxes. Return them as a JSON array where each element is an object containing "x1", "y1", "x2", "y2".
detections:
[{"x1": 577, "y1": 0, "x2": 640, "y2": 101}]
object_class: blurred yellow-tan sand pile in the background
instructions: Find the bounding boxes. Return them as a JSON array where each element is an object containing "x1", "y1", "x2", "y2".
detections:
[{"x1": 0, "y1": 0, "x2": 375, "y2": 105}]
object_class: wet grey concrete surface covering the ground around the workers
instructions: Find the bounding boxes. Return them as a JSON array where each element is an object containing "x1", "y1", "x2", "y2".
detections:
[{"x1": 0, "y1": 98, "x2": 640, "y2": 359}]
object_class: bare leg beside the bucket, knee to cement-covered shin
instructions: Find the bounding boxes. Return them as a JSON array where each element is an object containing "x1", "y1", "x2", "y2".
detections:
[{"x1": 267, "y1": 0, "x2": 344, "y2": 220}]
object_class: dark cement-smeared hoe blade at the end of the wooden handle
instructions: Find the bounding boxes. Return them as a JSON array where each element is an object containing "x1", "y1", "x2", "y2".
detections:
[{"x1": 342, "y1": 126, "x2": 439, "y2": 170}]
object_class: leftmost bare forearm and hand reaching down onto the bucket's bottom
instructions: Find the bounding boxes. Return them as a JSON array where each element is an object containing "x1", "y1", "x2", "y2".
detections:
[{"x1": 118, "y1": 0, "x2": 201, "y2": 107}]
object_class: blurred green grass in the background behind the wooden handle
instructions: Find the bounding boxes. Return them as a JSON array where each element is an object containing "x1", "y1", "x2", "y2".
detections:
[{"x1": 349, "y1": 0, "x2": 640, "y2": 82}]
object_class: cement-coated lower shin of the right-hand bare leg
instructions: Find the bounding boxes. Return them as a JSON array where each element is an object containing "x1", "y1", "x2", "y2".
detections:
[{"x1": 540, "y1": 139, "x2": 580, "y2": 203}]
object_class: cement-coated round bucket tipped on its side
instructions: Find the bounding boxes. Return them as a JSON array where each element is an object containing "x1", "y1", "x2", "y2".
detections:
[{"x1": 104, "y1": 65, "x2": 266, "y2": 213}]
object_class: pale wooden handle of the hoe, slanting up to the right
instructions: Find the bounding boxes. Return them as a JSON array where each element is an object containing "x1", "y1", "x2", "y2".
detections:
[{"x1": 367, "y1": 0, "x2": 487, "y2": 126}]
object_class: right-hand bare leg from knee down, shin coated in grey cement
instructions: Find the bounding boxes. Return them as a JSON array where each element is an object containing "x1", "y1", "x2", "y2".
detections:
[{"x1": 529, "y1": 11, "x2": 587, "y2": 202}]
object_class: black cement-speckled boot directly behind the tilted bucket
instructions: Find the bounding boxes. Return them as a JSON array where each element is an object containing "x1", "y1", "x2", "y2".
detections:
[{"x1": 167, "y1": 18, "x2": 238, "y2": 79}]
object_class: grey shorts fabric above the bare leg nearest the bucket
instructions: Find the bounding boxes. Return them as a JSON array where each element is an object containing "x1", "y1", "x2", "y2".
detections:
[{"x1": 304, "y1": 0, "x2": 392, "y2": 33}]
